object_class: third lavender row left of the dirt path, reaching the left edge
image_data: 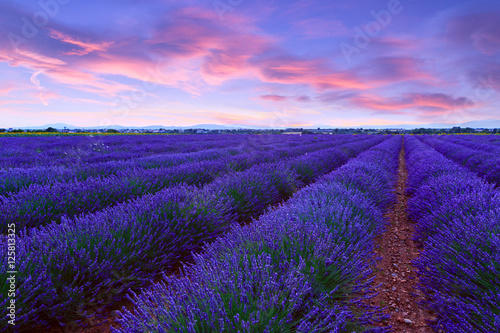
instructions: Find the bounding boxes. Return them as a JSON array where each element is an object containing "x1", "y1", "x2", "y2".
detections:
[{"x1": 0, "y1": 136, "x2": 371, "y2": 233}]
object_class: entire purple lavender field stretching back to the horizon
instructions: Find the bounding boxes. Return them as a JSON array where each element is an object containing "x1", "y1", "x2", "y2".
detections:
[{"x1": 0, "y1": 135, "x2": 500, "y2": 333}]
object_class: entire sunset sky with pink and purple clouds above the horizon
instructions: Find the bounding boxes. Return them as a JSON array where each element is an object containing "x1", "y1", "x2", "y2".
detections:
[{"x1": 0, "y1": 0, "x2": 500, "y2": 127}]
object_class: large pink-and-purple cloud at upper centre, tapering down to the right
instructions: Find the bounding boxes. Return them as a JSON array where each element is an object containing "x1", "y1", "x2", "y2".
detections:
[{"x1": 139, "y1": 8, "x2": 369, "y2": 90}]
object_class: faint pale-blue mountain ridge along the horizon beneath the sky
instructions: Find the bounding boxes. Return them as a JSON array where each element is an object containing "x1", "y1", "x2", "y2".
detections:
[{"x1": 10, "y1": 119, "x2": 500, "y2": 130}]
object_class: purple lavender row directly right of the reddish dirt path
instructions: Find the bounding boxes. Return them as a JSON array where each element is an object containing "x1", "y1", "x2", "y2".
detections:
[{"x1": 406, "y1": 137, "x2": 500, "y2": 333}]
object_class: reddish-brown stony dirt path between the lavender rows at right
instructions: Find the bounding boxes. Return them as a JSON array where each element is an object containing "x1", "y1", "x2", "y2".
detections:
[{"x1": 370, "y1": 139, "x2": 435, "y2": 333}]
